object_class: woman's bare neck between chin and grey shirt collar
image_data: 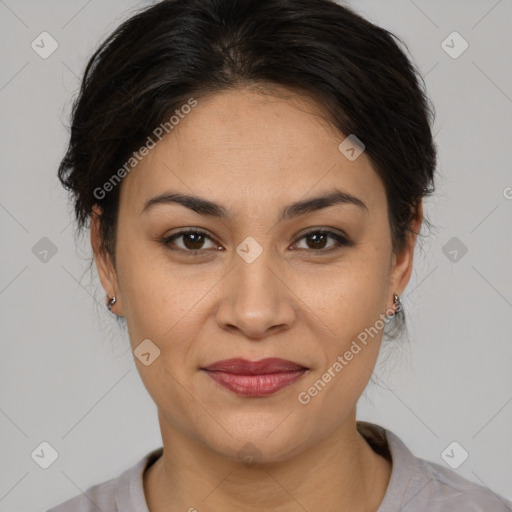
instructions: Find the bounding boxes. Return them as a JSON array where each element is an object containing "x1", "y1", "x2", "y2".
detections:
[{"x1": 144, "y1": 409, "x2": 391, "y2": 512}]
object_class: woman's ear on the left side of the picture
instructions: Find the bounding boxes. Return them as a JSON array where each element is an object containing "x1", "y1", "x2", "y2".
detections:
[{"x1": 91, "y1": 205, "x2": 124, "y2": 316}]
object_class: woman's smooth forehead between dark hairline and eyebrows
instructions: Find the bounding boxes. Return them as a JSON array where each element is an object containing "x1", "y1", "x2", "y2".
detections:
[{"x1": 121, "y1": 85, "x2": 385, "y2": 216}]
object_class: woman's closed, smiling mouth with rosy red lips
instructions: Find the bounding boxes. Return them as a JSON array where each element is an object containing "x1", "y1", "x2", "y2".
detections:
[{"x1": 201, "y1": 358, "x2": 309, "y2": 397}]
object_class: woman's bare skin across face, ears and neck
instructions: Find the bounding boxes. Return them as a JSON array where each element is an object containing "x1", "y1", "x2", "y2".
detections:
[{"x1": 91, "y1": 87, "x2": 422, "y2": 512}]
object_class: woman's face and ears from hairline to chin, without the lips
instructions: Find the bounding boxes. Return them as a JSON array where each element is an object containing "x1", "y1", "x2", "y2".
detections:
[{"x1": 91, "y1": 89, "x2": 421, "y2": 461}]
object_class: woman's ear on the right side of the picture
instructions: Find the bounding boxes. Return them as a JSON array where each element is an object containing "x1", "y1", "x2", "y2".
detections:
[{"x1": 387, "y1": 199, "x2": 423, "y2": 309}]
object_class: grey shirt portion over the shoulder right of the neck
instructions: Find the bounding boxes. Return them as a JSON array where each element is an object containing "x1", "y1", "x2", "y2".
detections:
[{"x1": 358, "y1": 422, "x2": 512, "y2": 512}]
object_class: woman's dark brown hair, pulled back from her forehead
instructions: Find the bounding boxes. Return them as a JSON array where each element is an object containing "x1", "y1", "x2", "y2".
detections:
[{"x1": 58, "y1": 0, "x2": 436, "y2": 340}]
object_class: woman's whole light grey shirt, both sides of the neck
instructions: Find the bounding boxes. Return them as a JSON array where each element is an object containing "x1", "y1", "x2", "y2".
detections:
[{"x1": 47, "y1": 421, "x2": 512, "y2": 512}]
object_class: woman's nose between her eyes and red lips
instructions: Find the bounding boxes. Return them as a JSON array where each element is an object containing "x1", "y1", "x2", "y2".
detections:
[{"x1": 216, "y1": 250, "x2": 297, "y2": 341}]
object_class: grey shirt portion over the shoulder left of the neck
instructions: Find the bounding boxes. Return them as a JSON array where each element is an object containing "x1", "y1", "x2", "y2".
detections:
[{"x1": 46, "y1": 447, "x2": 163, "y2": 512}]
